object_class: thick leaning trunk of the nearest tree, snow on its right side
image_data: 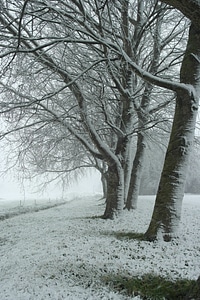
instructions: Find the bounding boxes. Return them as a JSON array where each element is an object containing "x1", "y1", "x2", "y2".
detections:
[{"x1": 146, "y1": 25, "x2": 200, "y2": 241}]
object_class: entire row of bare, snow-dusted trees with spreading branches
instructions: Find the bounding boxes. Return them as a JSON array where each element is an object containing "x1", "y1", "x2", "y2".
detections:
[{"x1": 0, "y1": 0, "x2": 200, "y2": 240}]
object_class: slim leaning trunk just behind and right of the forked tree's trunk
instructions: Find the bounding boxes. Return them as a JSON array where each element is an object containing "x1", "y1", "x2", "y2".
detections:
[{"x1": 125, "y1": 132, "x2": 146, "y2": 210}]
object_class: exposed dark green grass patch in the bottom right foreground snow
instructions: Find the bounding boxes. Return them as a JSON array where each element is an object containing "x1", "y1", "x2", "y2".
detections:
[{"x1": 104, "y1": 274, "x2": 200, "y2": 300}]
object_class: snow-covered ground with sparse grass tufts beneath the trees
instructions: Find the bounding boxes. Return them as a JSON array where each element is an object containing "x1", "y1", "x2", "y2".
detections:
[{"x1": 0, "y1": 195, "x2": 200, "y2": 300}]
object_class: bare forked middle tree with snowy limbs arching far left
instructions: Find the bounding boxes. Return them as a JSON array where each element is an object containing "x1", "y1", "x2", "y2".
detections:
[{"x1": 0, "y1": 1, "x2": 175, "y2": 218}]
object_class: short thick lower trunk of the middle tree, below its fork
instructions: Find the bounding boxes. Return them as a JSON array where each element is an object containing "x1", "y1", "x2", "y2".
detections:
[{"x1": 103, "y1": 165, "x2": 124, "y2": 219}]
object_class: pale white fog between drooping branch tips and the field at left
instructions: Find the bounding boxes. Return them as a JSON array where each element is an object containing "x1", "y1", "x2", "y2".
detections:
[{"x1": 0, "y1": 171, "x2": 101, "y2": 201}]
